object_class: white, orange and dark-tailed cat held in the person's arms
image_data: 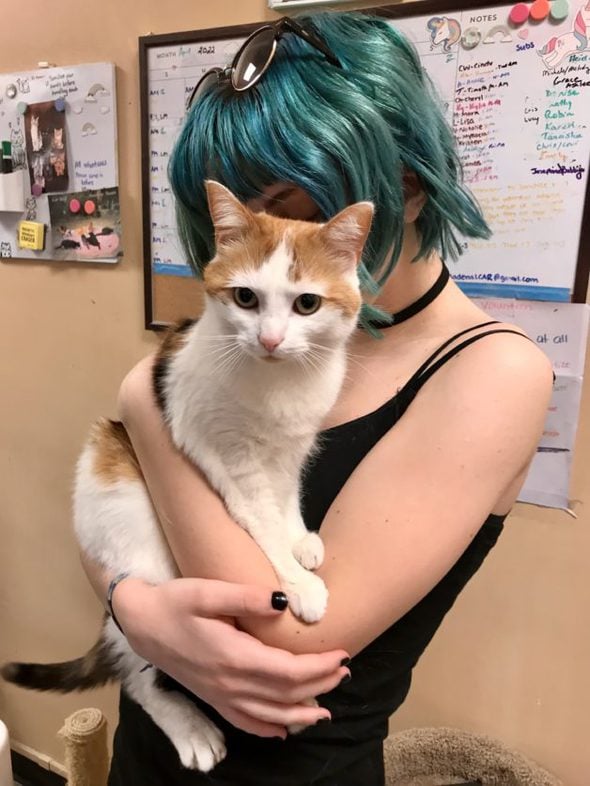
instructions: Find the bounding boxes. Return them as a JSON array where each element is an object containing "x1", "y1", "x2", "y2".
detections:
[{"x1": 2, "y1": 181, "x2": 373, "y2": 771}]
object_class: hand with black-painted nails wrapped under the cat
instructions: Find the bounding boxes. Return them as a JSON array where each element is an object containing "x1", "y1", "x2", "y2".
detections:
[{"x1": 113, "y1": 578, "x2": 349, "y2": 737}]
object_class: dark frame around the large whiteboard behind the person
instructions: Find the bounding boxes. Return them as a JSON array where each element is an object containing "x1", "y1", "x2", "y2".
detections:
[{"x1": 139, "y1": 0, "x2": 590, "y2": 330}]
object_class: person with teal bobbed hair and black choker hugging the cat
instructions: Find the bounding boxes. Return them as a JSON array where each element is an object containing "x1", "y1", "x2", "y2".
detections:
[{"x1": 80, "y1": 13, "x2": 552, "y2": 786}]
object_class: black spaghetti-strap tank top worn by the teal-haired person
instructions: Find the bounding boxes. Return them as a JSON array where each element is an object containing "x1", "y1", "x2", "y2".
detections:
[{"x1": 109, "y1": 322, "x2": 522, "y2": 786}]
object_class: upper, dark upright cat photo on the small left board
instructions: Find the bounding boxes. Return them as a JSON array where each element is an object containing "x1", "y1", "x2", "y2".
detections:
[{"x1": 24, "y1": 101, "x2": 69, "y2": 196}]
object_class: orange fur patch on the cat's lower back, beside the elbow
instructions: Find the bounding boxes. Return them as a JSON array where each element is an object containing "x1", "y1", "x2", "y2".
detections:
[{"x1": 90, "y1": 418, "x2": 143, "y2": 485}]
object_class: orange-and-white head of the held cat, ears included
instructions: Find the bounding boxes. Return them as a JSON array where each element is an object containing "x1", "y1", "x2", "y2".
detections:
[{"x1": 204, "y1": 182, "x2": 373, "y2": 364}]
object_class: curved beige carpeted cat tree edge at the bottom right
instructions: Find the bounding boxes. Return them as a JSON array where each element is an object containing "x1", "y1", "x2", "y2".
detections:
[{"x1": 385, "y1": 728, "x2": 564, "y2": 786}]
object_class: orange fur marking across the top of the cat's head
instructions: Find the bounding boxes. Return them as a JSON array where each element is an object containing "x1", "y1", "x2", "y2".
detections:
[{"x1": 204, "y1": 213, "x2": 361, "y2": 316}]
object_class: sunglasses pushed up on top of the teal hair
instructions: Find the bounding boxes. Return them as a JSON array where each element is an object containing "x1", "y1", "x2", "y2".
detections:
[{"x1": 186, "y1": 17, "x2": 342, "y2": 111}]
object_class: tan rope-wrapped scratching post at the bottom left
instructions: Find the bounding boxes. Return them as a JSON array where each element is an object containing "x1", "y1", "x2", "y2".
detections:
[{"x1": 59, "y1": 708, "x2": 109, "y2": 786}]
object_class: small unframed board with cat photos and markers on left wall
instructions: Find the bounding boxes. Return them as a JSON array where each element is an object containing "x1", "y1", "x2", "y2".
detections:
[{"x1": 0, "y1": 63, "x2": 122, "y2": 263}]
